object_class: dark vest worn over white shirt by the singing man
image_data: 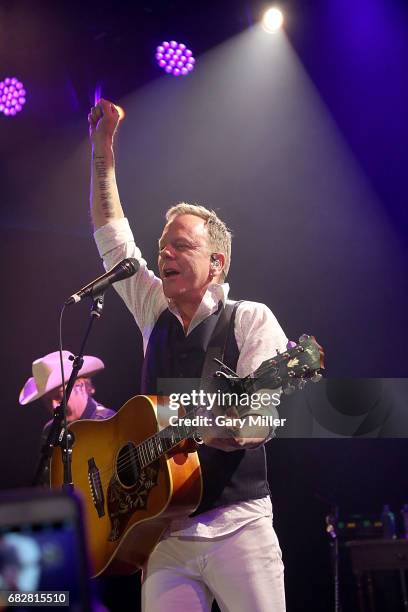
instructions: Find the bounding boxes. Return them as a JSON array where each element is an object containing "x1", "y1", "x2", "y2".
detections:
[{"x1": 141, "y1": 302, "x2": 269, "y2": 515}]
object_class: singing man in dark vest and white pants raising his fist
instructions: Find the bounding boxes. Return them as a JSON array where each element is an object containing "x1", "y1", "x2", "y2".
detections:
[{"x1": 89, "y1": 100, "x2": 286, "y2": 612}]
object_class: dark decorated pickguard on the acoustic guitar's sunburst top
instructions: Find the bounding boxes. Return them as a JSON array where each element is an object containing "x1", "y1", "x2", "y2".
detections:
[{"x1": 107, "y1": 461, "x2": 160, "y2": 542}]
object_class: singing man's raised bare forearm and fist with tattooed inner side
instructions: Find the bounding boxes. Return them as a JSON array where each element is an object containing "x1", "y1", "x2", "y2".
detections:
[{"x1": 88, "y1": 99, "x2": 124, "y2": 229}]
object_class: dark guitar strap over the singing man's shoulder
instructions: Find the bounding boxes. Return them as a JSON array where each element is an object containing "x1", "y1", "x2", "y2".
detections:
[{"x1": 200, "y1": 300, "x2": 243, "y2": 389}]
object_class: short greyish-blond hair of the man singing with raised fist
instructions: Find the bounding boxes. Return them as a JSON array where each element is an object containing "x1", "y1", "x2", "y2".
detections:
[{"x1": 166, "y1": 202, "x2": 232, "y2": 280}]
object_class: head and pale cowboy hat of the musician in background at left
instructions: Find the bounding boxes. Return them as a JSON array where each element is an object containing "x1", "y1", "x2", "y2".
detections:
[{"x1": 19, "y1": 351, "x2": 115, "y2": 427}]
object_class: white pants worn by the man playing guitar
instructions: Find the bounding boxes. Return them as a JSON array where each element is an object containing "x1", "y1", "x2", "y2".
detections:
[{"x1": 142, "y1": 517, "x2": 286, "y2": 612}]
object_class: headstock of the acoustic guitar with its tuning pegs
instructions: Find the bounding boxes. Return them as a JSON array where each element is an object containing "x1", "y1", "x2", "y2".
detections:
[{"x1": 246, "y1": 334, "x2": 324, "y2": 394}]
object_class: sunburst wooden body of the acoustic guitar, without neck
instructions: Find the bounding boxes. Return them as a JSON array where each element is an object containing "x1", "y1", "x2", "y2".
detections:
[{"x1": 50, "y1": 396, "x2": 202, "y2": 576}]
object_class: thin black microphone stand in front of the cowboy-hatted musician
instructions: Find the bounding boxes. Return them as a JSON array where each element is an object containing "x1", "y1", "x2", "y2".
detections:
[{"x1": 33, "y1": 294, "x2": 106, "y2": 491}]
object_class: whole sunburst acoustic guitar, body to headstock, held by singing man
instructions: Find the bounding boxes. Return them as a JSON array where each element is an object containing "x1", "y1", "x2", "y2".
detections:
[{"x1": 50, "y1": 335, "x2": 324, "y2": 576}]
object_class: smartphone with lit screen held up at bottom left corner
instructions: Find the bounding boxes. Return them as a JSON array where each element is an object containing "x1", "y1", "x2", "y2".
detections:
[{"x1": 0, "y1": 490, "x2": 91, "y2": 612}]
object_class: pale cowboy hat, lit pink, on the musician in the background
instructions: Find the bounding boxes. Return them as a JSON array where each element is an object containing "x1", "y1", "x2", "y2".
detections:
[{"x1": 18, "y1": 351, "x2": 105, "y2": 406}]
